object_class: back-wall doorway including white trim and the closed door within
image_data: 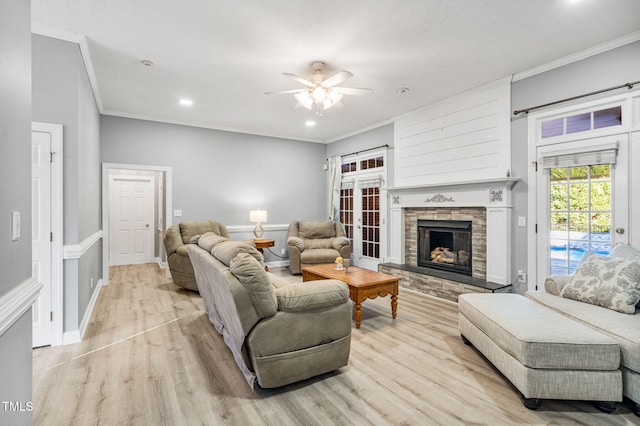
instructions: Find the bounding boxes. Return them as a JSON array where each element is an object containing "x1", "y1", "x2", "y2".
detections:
[{"x1": 102, "y1": 163, "x2": 172, "y2": 284}]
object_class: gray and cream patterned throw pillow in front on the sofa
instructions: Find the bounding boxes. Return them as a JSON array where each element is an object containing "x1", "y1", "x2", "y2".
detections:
[{"x1": 560, "y1": 252, "x2": 640, "y2": 314}]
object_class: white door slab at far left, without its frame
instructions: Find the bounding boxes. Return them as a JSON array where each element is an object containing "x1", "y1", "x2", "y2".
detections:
[{"x1": 31, "y1": 132, "x2": 52, "y2": 348}]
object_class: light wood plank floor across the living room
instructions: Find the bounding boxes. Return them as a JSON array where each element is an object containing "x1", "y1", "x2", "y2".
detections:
[{"x1": 33, "y1": 264, "x2": 640, "y2": 426}]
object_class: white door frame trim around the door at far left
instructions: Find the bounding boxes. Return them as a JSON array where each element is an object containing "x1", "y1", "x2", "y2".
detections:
[{"x1": 30, "y1": 121, "x2": 64, "y2": 346}]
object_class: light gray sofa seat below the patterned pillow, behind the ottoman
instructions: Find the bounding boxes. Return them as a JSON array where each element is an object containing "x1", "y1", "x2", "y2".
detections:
[{"x1": 525, "y1": 291, "x2": 640, "y2": 371}]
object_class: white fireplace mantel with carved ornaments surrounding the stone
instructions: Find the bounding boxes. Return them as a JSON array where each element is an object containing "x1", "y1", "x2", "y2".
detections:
[{"x1": 386, "y1": 178, "x2": 519, "y2": 285}]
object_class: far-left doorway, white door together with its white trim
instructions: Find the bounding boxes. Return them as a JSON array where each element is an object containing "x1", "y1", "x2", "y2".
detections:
[{"x1": 31, "y1": 122, "x2": 64, "y2": 348}]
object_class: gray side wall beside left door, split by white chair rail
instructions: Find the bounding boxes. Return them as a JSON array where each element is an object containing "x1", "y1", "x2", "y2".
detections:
[{"x1": 32, "y1": 35, "x2": 102, "y2": 332}]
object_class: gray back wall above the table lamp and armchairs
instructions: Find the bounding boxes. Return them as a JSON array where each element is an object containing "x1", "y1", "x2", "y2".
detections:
[{"x1": 100, "y1": 116, "x2": 326, "y2": 225}]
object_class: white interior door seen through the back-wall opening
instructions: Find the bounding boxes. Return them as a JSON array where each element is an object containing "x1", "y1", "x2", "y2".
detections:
[{"x1": 109, "y1": 175, "x2": 155, "y2": 265}]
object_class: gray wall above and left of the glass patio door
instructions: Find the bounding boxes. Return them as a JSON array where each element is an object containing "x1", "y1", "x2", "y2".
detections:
[{"x1": 511, "y1": 42, "x2": 640, "y2": 293}]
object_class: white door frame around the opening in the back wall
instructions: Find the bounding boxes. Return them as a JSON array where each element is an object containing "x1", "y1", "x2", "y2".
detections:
[{"x1": 102, "y1": 163, "x2": 173, "y2": 285}]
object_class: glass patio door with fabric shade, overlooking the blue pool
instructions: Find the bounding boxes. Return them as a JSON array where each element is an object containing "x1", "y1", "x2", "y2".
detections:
[{"x1": 536, "y1": 134, "x2": 629, "y2": 288}]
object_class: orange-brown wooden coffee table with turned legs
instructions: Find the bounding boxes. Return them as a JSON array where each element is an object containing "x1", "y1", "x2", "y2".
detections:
[{"x1": 302, "y1": 263, "x2": 400, "y2": 328}]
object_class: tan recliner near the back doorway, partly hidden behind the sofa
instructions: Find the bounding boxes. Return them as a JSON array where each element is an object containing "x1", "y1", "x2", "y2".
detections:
[{"x1": 164, "y1": 220, "x2": 230, "y2": 291}]
